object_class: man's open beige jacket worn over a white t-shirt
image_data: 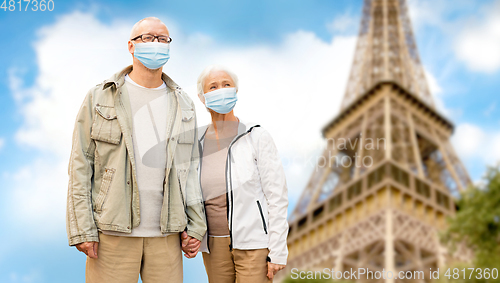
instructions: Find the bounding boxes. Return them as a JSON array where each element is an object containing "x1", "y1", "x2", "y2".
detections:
[{"x1": 66, "y1": 66, "x2": 206, "y2": 245}]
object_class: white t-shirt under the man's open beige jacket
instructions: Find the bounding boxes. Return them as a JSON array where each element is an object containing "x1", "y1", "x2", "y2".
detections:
[{"x1": 102, "y1": 75, "x2": 171, "y2": 237}]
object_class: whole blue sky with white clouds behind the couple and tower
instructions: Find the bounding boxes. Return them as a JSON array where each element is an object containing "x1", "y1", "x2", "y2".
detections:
[{"x1": 0, "y1": 0, "x2": 500, "y2": 283}]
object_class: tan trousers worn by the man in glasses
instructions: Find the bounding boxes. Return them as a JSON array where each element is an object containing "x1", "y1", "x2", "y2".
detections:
[{"x1": 85, "y1": 232, "x2": 182, "y2": 283}]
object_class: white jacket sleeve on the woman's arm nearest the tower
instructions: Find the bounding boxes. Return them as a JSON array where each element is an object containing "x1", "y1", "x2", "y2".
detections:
[{"x1": 257, "y1": 129, "x2": 288, "y2": 264}]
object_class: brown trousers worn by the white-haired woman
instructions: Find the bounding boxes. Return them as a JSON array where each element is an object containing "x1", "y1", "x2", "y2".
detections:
[{"x1": 203, "y1": 237, "x2": 272, "y2": 283}]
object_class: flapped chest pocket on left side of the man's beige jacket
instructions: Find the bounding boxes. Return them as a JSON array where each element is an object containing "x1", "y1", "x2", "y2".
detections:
[{"x1": 90, "y1": 104, "x2": 122, "y2": 144}]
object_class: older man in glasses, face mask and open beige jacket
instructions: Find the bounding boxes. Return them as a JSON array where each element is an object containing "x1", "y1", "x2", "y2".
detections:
[{"x1": 67, "y1": 18, "x2": 206, "y2": 283}]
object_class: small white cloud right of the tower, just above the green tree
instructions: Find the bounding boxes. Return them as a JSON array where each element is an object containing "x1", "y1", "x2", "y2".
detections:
[{"x1": 451, "y1": 123, "x2": 500, "y2": 165}]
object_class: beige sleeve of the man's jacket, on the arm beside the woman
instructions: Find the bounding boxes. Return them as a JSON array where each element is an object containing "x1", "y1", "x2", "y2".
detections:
[{"x1": 186, "y1": 105, "x2": 207, "y2": 241}]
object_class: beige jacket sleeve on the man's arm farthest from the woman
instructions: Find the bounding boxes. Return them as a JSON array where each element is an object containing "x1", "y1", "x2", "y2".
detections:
[{"x1": 66, "y1": 91, "x2": 99, "y2": 246}]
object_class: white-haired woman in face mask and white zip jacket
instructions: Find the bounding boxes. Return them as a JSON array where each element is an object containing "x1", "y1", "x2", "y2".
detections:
[{"x1": 183, "y1": 66, "x2": 288, "y2": 283}]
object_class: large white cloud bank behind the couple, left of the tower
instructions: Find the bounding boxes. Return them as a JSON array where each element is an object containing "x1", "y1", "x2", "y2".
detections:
[{"x1": 10, "y1": 12, "x2": 356, "y2": 237}]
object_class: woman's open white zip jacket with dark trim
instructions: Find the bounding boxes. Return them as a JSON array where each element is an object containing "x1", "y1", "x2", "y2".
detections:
[{"x1": 198, "y1": 120, "x2": 288, "y2": 264}]
